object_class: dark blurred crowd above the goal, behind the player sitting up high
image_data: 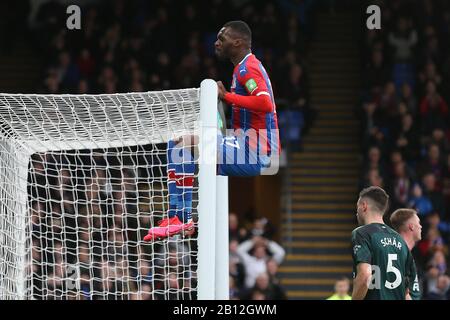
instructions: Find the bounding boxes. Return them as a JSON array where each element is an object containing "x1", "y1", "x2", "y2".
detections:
[{"x1": 26, "y1": 0, "x2": 317, "y2": 146}]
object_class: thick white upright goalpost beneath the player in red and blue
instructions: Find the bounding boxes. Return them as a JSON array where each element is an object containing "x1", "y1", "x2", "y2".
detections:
[{"x1": 197, "y1": 79, "x2": 229, "y2": 300}]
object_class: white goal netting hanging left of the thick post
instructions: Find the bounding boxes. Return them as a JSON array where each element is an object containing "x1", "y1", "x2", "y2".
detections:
[{"x1": 0, "y1": 89, "x2": 200, "y2": 299}]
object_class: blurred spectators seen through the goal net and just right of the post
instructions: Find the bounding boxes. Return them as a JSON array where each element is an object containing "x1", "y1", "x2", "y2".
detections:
[{"x1": 27, "y1": 146, "x2": 286, "y2": 300}]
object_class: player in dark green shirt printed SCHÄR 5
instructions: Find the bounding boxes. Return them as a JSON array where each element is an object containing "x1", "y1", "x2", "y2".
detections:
[{"x1": 352, "y1": 187, "x2": 416, "y2": 300}]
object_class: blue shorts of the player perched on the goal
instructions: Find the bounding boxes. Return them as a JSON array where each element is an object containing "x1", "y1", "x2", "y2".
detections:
[{"x1": 217, "y1": 134, "x2": 270, "y2": 177}]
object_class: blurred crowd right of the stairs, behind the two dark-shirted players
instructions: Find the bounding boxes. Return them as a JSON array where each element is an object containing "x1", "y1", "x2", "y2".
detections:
[{"x1": 357, "y1": 0, "x2": 450, "y2": 299}]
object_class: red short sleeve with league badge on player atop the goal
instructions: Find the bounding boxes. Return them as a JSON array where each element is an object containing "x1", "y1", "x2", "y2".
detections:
[{"x1": 237, "y1": 64, "x2": 270, "y2": 97}]
